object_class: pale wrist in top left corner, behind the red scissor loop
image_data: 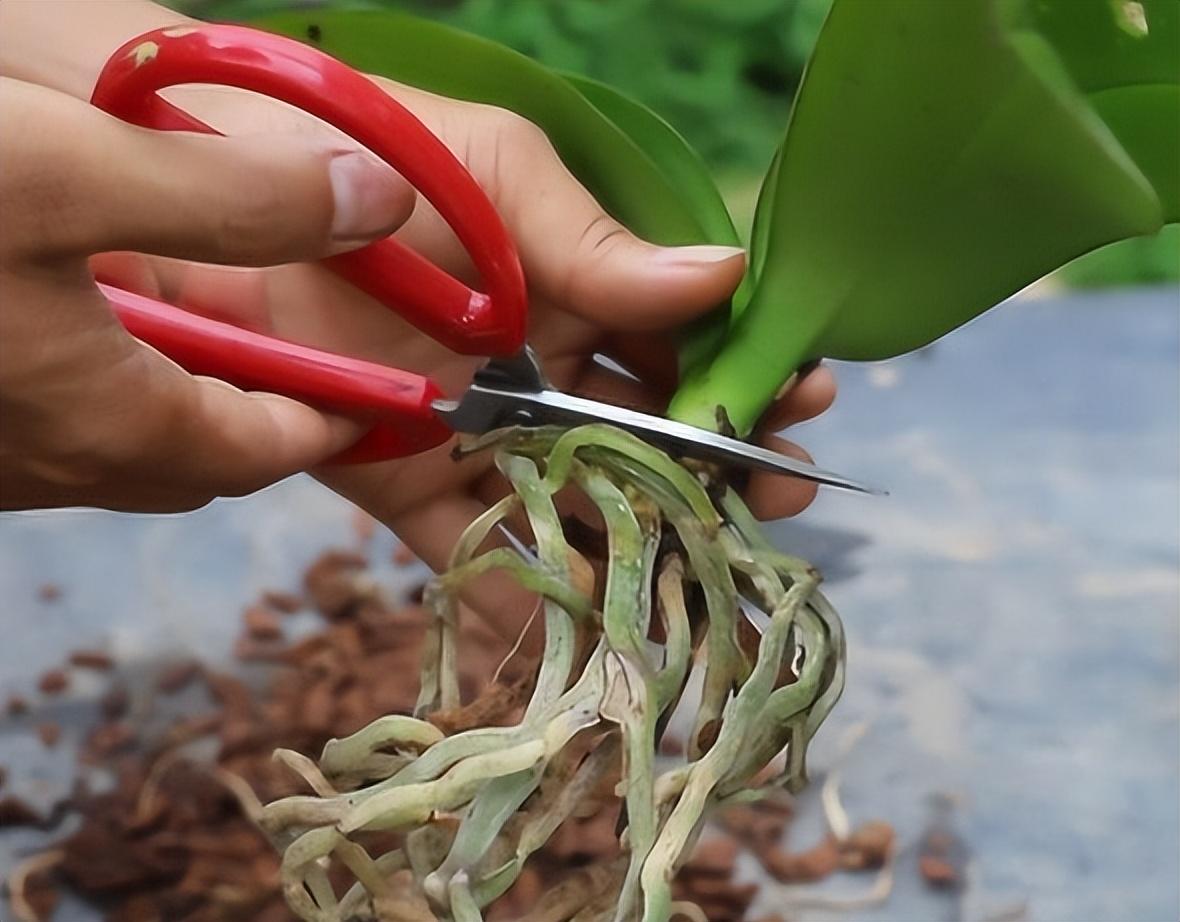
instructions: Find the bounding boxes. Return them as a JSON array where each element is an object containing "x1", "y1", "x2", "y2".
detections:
[{"x1": 0, "y1": 0, "x2": 194, "y2": 99}]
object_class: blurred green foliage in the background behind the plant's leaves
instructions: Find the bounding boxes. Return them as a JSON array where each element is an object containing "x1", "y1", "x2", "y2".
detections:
[{"x1": 169, "y1": 0, "x2": 1180, "y2": 287}]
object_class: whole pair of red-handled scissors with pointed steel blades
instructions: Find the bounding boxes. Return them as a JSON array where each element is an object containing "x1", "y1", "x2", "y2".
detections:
[{"x1": 91, "y1": 25, "x2": 874, "y2": 492}]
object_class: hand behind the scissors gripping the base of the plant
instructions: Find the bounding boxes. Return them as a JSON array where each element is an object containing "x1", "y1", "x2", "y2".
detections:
[{"x1": 96, "y1": 80, "x2": 834, "y2": 628}]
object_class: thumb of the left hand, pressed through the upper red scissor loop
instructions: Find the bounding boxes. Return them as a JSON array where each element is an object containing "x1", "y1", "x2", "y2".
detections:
[{"x1": 5, "y1": 78, "x2": 415, "y2": 266}]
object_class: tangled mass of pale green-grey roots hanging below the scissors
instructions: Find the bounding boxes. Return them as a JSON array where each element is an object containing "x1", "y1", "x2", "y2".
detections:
[{"x1": 261, "y1": 426, "x2": 844, "y2": 922}]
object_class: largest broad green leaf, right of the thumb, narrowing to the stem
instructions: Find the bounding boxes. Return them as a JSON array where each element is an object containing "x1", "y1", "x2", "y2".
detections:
[{"x1": 670, "y1": 0, "x2": 1180, "y2": 433}]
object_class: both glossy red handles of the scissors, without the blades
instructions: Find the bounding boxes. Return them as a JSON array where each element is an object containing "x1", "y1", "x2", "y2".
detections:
[{"x1": 92, "y1": 25, "x2": 526, "y2": 462}]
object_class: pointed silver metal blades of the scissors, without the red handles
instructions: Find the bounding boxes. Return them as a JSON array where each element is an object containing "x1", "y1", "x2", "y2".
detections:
[{"x1": 434, "y1": 352, "x2": 884, "y2": 493}]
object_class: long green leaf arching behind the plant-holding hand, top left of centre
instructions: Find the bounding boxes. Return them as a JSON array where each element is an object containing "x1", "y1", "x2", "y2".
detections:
[{"x1": 256, "y1": 9, "x2": 732, "y2": 244}]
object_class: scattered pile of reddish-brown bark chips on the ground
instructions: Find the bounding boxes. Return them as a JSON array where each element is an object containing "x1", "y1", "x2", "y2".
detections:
[{"x1": 0, "y1": 543, "x2": 892, "y2": 922}]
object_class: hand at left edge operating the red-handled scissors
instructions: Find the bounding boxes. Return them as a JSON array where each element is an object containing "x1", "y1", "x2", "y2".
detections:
[{"x1": 0, "y1": 78, "x2": 414, "y2": 511}]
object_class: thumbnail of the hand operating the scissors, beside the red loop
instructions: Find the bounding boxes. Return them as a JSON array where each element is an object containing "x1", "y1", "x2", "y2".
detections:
[{"x1": 328, "y1": 151, "x2": 406, "y2": 249}]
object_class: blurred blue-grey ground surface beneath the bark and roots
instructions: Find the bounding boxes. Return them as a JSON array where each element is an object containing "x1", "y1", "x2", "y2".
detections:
[{"x1": 0, "y1": 289, "x2": 1180, "y2": 922}]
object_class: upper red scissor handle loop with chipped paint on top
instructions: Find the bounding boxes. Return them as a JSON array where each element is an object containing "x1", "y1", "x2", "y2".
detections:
[{"x1": 91, "y1": 25, "x2": 527, "y2": 355}]
